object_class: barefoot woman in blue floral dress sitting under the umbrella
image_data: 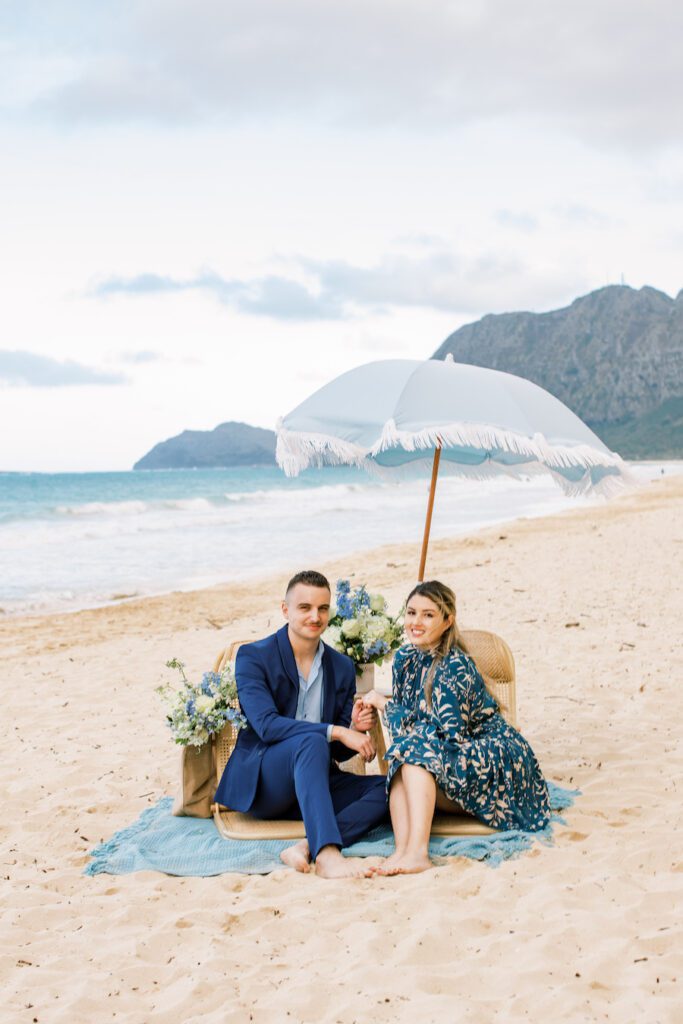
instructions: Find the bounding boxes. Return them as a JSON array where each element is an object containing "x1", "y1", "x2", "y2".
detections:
[{"x1": 364, "y1": 580, "x2": 550, "y2": 874}]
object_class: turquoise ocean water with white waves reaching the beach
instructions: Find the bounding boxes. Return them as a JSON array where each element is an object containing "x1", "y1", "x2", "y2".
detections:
[{"x1": 0, "y1": 463, "x2": 683, "y2": 614}]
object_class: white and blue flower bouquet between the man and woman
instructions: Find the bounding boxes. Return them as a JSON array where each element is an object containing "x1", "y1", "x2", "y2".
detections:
[{"x1": 323, "y1": 580, "x2": 403, "y2": 673}]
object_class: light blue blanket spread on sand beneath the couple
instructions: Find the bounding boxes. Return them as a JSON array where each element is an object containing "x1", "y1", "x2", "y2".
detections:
[{"x1": 84, "y1": 782, "x2": 580, "y2": 877}]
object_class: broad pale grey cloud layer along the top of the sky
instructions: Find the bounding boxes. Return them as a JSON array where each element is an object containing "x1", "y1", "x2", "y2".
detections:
[{"x1": 8, "y1": 0, "x2": 683, "y2": 150}]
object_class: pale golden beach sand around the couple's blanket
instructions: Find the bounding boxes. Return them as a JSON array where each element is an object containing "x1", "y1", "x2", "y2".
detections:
[{"x1": 0, "y1": 477, "x2": 683, "y2": 1024}]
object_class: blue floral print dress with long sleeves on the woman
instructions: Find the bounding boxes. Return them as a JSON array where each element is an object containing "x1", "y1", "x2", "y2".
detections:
[{"x1": 383, "y1": 644, "x2": 550, "y2": 831}]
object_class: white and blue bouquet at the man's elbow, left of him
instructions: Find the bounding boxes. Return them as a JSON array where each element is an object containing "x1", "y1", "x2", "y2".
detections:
[{"x1": 157, "y1": 657, "x2": 247, "y2": 746}]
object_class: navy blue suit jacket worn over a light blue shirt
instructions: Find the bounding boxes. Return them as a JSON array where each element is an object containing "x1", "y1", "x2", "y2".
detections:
[{"x1": 214, "y1": 626, "x2": 355, "y2": 811}]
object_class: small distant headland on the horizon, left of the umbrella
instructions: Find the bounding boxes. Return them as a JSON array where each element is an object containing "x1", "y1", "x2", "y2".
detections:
[{"x1": 133, "y1": 421, "x2": 275, "y2": 469}]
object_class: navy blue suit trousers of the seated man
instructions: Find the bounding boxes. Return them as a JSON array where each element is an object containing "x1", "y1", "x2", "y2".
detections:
[{"x1": 249, "y1": 732, "x2": 387, "y2": 860}]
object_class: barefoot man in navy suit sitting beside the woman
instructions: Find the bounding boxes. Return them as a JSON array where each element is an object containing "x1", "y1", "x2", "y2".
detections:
[{"x1": 215, "y1": 570, "x2": 387, "y2": 879}]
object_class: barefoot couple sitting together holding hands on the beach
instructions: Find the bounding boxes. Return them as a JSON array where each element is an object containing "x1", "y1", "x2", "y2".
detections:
[{"x1": 215, "y1": 571, "x2": 550, "y2": 878}]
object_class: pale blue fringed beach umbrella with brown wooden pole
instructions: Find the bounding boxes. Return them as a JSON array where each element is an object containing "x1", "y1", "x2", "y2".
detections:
[{"x1": 276, "y1": 356, "x2": 628, "y2": 580}]
